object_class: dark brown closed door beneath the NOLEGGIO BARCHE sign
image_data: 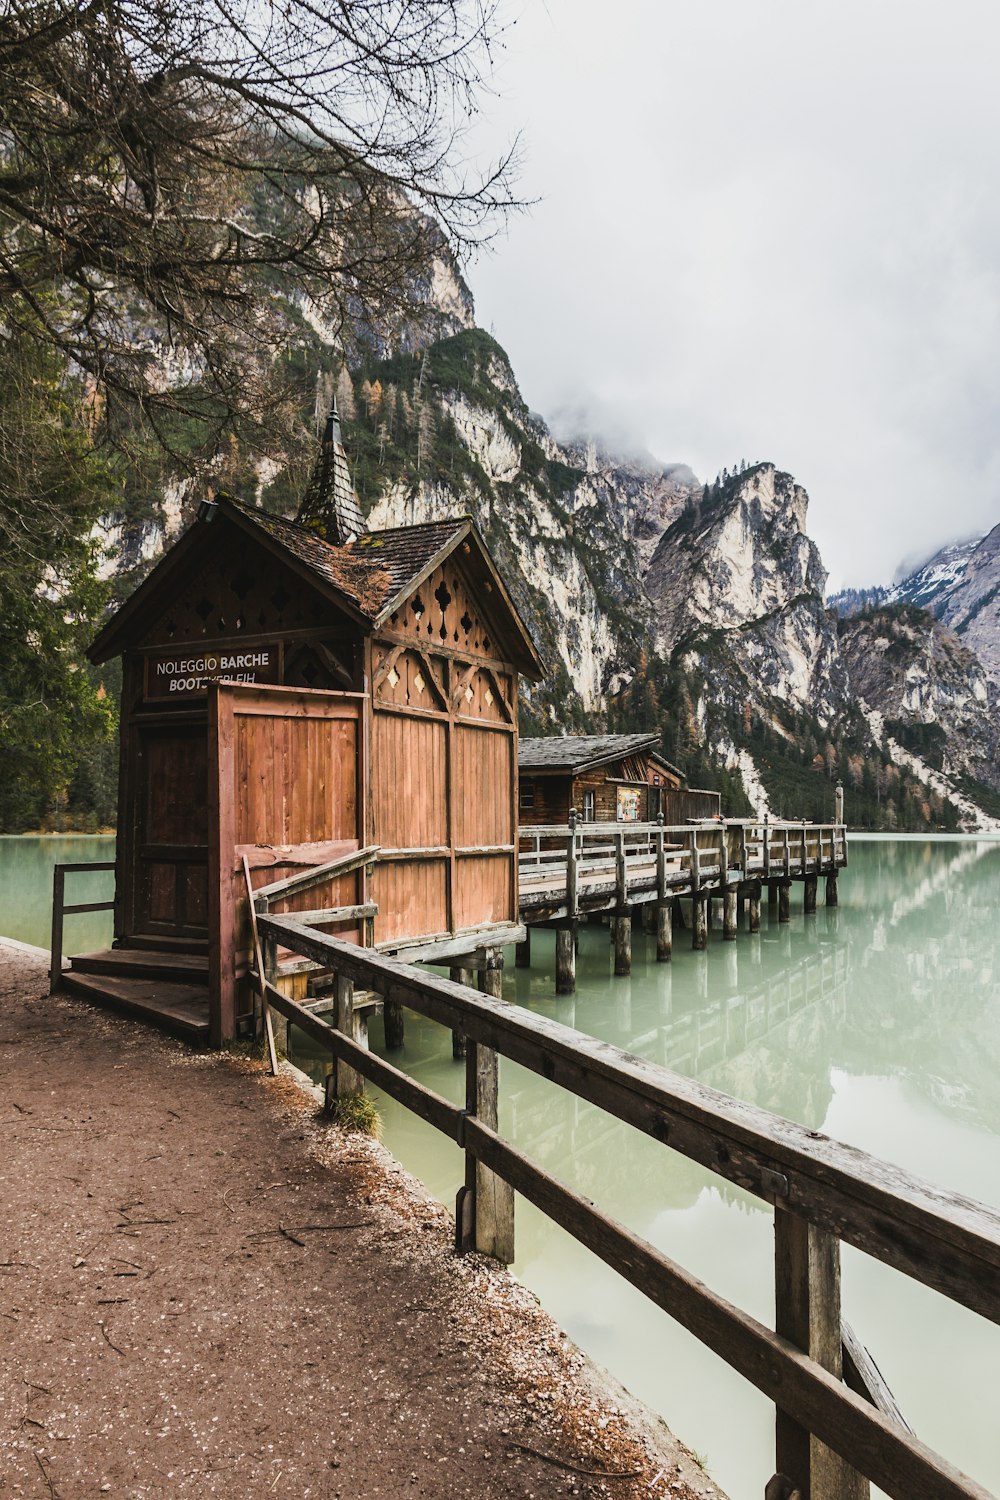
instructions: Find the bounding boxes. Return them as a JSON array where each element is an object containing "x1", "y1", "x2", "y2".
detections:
[{"x1": 129, "y1": 716, "x2": 208, "y2": 939}]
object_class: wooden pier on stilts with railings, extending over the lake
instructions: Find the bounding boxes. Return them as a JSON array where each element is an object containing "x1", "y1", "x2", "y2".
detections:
[{"x1": 519, "y1": 815, "x2": 847, "y2": 995}]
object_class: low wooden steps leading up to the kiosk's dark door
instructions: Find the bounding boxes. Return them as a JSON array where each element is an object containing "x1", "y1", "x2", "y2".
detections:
[{"x1": 63, "y1": 948, "x2": 208, "y2": 1047}]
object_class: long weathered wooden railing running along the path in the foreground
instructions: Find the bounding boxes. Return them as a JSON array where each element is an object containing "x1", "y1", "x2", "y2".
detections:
[{"x1": 261, "y1": 915, "x2": 1000, "y2": 1500}]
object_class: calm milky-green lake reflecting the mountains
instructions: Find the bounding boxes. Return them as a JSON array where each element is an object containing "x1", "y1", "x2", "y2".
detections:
[{"x1": 0, "y1": 836, "x2": 1000, "y2": 1500}]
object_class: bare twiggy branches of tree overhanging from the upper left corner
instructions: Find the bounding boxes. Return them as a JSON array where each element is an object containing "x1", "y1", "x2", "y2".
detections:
[{"x1": 0, "y1": 0, "x2": 514, "y2": 455}]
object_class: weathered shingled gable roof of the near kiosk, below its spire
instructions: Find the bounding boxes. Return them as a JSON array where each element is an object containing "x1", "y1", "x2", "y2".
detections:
[{"x1": 87, "y1": 495, "x2": 544, "y2": 680}]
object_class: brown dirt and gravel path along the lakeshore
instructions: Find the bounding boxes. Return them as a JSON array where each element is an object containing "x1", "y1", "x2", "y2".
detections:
[{"x1": 0, "y1": 942, "x2": 718, "y2": 1500}]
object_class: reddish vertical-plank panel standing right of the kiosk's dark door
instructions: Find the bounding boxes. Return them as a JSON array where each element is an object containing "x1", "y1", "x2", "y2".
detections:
[{"x1": 208, "y1": 683, "x2": 367, "y2": 1043}]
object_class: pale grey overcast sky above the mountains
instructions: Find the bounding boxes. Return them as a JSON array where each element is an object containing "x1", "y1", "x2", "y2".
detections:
[{"x1": 469, "y1": 0, "x2": 1000, "y2": 587}]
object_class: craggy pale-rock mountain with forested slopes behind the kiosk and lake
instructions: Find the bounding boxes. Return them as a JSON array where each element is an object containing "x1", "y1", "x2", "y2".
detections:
[{"x1": 91, "y1": 231, "x2": 1000, "y2": 828}]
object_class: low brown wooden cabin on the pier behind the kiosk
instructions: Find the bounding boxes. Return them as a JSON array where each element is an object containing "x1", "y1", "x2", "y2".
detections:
[{"x1": 517, "y1": 734, "x2": 720, "y2": 828}]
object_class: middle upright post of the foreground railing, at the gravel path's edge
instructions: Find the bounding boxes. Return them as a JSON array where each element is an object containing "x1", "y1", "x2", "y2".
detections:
[{"x1": 456, "y1": 950, "x2": 514, "y2": 1266}]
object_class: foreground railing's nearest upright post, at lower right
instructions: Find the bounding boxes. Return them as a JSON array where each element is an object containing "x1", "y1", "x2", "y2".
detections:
[{"x1": 774, "y1": 1206, "x2": 870, "y2": 1500}]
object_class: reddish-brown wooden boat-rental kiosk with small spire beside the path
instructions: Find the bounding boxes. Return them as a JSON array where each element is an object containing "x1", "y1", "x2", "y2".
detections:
[{"x1": 81, "y1": 468, "x2": 541, "y2": 1044}]
